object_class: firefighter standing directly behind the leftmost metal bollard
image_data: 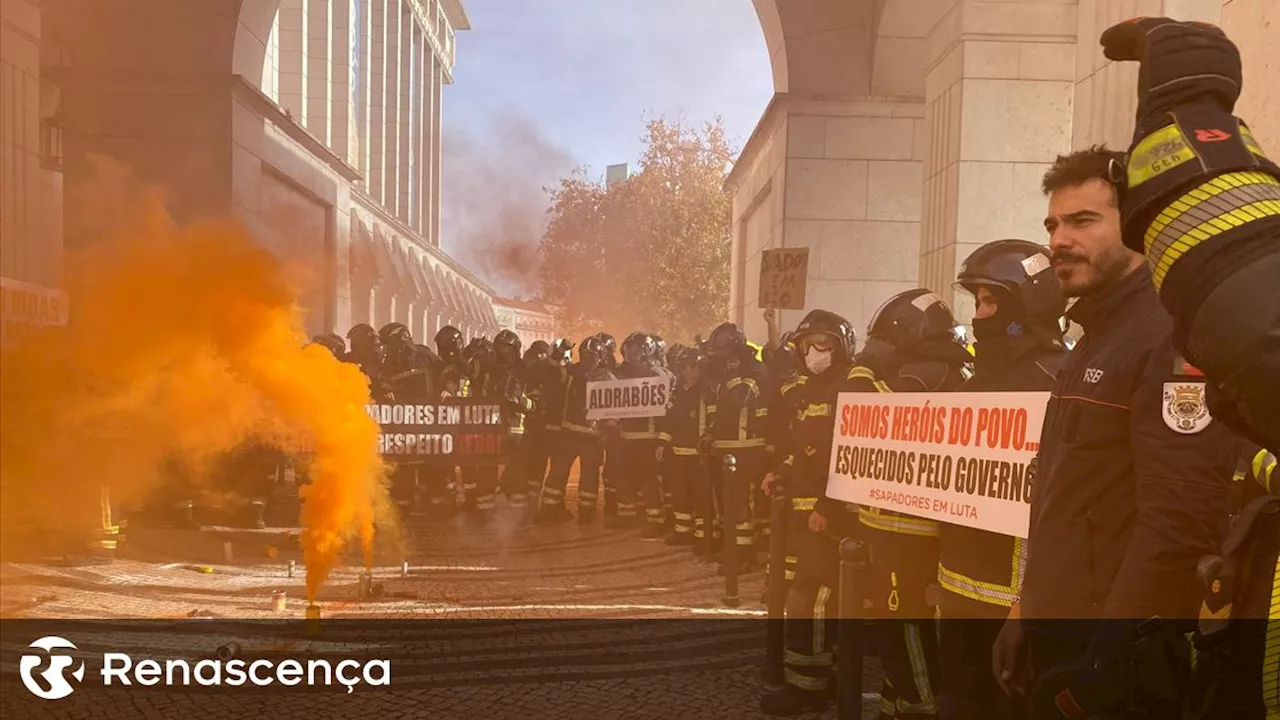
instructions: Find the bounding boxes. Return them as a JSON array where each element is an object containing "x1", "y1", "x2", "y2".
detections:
[{"x1": 704, "y1": 323, "x2": 769, "y2": 573}]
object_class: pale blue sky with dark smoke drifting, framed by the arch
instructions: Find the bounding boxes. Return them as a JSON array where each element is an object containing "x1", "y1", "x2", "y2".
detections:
[{"x1": 442, "y1": 0, "x2": 773, "y2": 297}]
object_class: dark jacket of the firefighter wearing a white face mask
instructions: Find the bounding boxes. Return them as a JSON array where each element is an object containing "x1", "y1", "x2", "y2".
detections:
[{"x1": 774, "y1": 363, "x2": 851, "y2": 511}]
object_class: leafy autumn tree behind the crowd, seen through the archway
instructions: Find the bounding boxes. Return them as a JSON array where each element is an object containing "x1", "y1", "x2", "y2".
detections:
[{"x1": 540, "y1": 118, "x2": 733, "y2": 343}]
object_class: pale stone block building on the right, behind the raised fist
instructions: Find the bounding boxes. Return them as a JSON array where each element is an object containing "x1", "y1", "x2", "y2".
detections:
[{"x1": 727, "y1": 0, "x2": 1280, "y2": 338}]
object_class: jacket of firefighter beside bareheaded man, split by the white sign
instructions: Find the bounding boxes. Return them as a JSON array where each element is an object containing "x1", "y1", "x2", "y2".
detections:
[{"x1": 938, "y1": 336, "x2": 1066, "y2": 618}]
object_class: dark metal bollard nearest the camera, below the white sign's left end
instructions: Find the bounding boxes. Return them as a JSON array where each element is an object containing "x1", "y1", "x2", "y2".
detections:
[{"x1": 836, "y1": 538, "x2": 870, "y2": 720}]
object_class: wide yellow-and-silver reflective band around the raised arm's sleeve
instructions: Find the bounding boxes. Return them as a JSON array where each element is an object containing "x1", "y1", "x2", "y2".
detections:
[{"x1": 1146, "y1": 171, "x2": 1280, "y2": 290}]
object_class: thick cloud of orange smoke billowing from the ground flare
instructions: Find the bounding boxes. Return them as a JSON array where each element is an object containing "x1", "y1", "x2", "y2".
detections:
[{"x1": 0, "y1": 172, "x2": 385, "y2": 598}]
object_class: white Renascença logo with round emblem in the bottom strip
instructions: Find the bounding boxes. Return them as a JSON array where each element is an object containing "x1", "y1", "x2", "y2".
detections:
[{"x1": 20, "y1": 635, "x2": 392, "y2": 700}]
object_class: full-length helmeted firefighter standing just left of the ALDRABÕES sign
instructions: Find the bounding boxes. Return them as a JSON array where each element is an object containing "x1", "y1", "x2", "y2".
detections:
[{"x1": 541, "y1": 336, "x2": 614, "y2": 525}]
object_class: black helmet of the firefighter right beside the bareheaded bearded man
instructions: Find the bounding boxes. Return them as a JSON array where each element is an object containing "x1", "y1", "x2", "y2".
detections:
[{"x1": 955, "y1": 240, "x2": 1066, "y2": 327}]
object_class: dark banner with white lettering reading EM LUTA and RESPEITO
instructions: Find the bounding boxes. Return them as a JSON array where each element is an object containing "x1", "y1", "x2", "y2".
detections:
[{"x1": 365, "y1": 397, "x2": 511, "y2": 465}]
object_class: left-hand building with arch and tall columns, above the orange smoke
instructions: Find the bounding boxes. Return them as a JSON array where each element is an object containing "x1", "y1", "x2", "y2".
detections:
[{"x1": 0, "y1": 0, "x2": 497, "y2": 341}]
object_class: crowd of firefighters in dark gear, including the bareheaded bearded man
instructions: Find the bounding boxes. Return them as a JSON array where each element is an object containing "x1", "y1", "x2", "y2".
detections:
[{"x1": 316, "y1": 140, "x2": 1280, "y2": 719}]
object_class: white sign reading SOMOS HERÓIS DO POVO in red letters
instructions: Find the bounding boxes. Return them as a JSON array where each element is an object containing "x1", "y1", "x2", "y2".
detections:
[{"x1": 827, "y1": 392, "x2": 1050, "y2": 538}]
